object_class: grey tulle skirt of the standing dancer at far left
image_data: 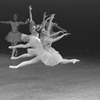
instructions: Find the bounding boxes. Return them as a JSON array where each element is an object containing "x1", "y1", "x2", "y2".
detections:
[{"x1": 5, "y1": 31, "x2": 21, "y2": 42}]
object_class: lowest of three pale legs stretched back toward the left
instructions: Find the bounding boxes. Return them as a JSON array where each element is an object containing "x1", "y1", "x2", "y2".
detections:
[{"x1": 9, "y1": 57, "x2": 39, "y2": 69}]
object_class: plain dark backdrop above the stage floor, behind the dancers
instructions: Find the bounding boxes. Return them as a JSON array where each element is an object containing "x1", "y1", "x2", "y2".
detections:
[{"x1": 0, "y1": 0, "x2": 100, "y2": 55}]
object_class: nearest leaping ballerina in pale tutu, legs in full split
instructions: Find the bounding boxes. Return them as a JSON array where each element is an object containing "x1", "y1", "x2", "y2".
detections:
[{"x1": 9, "y1": 14, "x2": 79, "y2": 68}]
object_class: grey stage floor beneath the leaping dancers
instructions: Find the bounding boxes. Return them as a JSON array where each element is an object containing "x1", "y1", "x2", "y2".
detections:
[{"x1": 0, "y1": 55, "x2": 100, "y2": 100}]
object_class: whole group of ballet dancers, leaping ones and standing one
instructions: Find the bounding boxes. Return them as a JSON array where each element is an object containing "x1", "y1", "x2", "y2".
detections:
[{"x1": 0, "y1": 6, "x2": 80, "y2": 69}]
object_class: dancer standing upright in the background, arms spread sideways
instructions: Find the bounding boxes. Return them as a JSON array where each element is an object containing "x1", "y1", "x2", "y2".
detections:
[{"x1": 0, "y1": 14, "x2": 27, "y2": 57}]
